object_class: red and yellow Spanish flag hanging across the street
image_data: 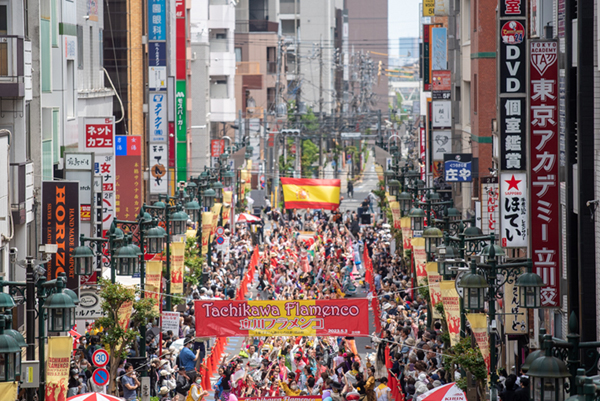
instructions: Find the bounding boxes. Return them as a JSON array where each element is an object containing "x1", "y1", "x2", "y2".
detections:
[{"x1": 281, "y1": 178, "x2": 340, "y2": 210}]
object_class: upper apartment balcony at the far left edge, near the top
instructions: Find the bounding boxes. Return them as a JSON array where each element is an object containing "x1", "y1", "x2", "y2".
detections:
[{"x1": 0, "y1": 35, "x2": 31, "y2": 97}]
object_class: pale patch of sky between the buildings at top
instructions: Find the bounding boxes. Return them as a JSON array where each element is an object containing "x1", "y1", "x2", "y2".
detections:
[{"x1": 388, "y1": 0, "x2": 420, "y2": 56}]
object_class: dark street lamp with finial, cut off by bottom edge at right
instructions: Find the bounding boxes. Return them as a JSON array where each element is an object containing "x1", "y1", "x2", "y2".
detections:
[{"x1": 527, "y1": 334, "x2": 571, "y2": 401}]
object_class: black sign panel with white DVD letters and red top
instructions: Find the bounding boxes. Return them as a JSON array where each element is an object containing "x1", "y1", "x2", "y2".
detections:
[{"x1": 500, "y1": 20, "x2": 527, "y2": 94}]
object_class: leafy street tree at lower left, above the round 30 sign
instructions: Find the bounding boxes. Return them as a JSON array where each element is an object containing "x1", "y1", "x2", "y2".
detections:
[{"x1": 94, "y1": 278, "x2": 158, "y2": 394}]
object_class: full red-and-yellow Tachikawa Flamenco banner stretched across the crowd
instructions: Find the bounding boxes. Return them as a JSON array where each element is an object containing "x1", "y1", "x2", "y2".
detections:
[{"x1": 194, "y1": 298, "x2": 369, "y2": 337}]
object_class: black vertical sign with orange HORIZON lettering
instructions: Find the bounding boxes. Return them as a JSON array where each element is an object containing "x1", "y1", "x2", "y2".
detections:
[{"x1": 42, "y1": 181, "x2": 79, "y2": 289}]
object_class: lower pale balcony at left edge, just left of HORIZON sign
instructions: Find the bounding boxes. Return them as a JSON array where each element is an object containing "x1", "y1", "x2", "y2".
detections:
[{"x1": 10, "y1": 161, "x2": 33, "y2": 225}]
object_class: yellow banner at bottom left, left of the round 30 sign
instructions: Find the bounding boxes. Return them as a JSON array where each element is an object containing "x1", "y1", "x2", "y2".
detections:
[{"x1": 45, "y1": 336, "x2": 73, "y2": 400}]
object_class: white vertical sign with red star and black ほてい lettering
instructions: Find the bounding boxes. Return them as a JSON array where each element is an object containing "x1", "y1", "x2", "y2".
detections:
[{"x1": 500, "y1": 173, "x2": 529, "y2": 248}]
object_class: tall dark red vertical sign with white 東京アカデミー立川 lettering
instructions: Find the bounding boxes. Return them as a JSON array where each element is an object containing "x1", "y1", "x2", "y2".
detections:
[{"x1": 529, "y1": 40, "x2": 561, "y2": 307}]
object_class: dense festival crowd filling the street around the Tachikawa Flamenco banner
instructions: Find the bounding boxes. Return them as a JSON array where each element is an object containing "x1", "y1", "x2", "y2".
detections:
[{"x1": 58, "y1": 192, "x2": 528, "y2": 401}]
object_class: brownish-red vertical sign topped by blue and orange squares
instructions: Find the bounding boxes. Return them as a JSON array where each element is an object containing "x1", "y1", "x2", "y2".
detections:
[{"x1": 115, "y1": 135, "x2": 143, "y2": 220}]
